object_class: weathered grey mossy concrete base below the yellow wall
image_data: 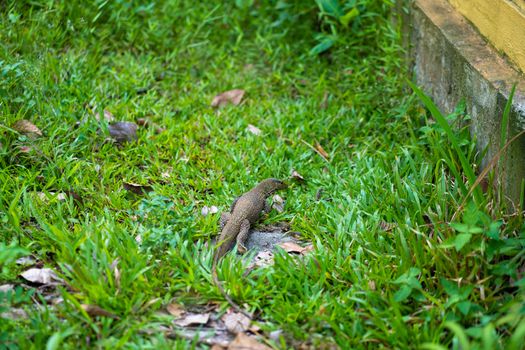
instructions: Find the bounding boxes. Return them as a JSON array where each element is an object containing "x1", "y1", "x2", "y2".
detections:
[{"x1": 410, "y1": 0, "x2": 525, "y2": 206}]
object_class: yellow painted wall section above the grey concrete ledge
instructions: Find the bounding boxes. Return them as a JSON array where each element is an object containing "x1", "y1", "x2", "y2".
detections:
[{"x1": 449, "y1": 0, "x2": 525, "y2": 72}]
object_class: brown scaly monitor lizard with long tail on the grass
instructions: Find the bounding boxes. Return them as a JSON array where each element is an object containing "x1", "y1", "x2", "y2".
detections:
[{"x1": 212, "y1": 178, "x2": 287, "y2": 318}]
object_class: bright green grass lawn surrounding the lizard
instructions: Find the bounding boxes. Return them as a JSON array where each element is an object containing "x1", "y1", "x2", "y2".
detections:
[{"x1": 0, "y1": 1, "x2": 525, "y2": 349}]
